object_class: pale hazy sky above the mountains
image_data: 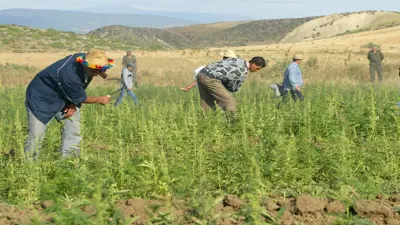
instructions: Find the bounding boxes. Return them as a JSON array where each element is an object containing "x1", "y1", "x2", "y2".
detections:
[{"x1": 0, "y1": 0, "x2": 400, "y2": 19}]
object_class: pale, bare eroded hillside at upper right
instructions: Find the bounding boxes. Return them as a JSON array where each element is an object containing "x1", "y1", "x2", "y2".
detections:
[{"x1": 280, "y1": 11, "x2": 400, "y2": 43}]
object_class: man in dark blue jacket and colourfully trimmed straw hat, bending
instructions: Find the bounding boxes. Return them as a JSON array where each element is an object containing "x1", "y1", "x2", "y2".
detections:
[{"x1": 24, "y1": 50, "x2": 114, "y2": 158}]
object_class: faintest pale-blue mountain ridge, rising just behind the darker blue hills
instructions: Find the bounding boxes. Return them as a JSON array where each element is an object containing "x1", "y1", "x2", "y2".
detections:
[{"x1": 81, "y1": 3, "x2": 254, "y2": 25}]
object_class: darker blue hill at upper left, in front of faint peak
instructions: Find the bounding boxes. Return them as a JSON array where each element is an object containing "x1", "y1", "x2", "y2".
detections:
[{"x1": 0, "y1": 9, "x2": 198, "y2": 33}]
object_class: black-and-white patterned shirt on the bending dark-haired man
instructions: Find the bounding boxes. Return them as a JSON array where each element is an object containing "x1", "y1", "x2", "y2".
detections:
[{"x1": 200, "y1": 58, "x2": 249, "y2": 92}]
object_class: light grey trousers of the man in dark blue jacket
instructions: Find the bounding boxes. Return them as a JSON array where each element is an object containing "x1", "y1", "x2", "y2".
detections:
[{"x1": 25, "y1": 108, "x2": 82, "y2": 159}]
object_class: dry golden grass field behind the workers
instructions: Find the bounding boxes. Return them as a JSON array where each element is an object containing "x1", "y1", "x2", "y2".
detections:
[{"x1": 0, "y1": 27, "x2": 400, "y2": 89}]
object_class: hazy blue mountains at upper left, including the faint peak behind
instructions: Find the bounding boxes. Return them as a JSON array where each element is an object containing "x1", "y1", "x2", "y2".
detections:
[{"x1": 0, "y1": 5, "x2": 252, "y2": 33}]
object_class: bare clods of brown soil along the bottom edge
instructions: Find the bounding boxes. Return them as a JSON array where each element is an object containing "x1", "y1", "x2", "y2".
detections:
[{"x1": 0, "y1": 194, "x2": 400, "y2": 225}]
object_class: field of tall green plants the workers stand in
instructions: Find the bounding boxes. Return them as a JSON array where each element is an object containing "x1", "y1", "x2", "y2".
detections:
[{"x1": 0, "y1": 72, "x2": 400, "y2": 224}]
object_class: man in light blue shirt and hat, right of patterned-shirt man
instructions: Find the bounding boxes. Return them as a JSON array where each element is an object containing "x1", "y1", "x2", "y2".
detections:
[{"x1": 282, "y1": 54, "x2": 304, "y2": 102}]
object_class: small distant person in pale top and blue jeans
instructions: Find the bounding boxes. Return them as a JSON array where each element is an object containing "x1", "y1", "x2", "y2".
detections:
[{"x1": 114, "y1": 63, "x2": 138, "y2": 107}]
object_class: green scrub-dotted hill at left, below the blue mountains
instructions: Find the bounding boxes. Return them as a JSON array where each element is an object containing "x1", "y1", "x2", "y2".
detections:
[{"x1": 0, "y1": 25, "x2": 130, "y2": 52}]
